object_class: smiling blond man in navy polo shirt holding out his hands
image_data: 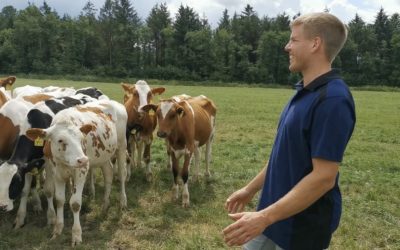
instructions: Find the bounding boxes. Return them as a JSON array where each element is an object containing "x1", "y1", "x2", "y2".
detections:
[{"x1": 223, "y1": 13, "x2": 355, "y2": 250}]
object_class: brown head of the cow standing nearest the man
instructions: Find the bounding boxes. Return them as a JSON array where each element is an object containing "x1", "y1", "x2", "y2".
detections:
[{"x1": 143, "y1": 99, "x2": 185, "y2": 138}]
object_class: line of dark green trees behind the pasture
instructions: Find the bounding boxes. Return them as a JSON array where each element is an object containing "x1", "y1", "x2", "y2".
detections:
[{"x1": 0, "y1": 0, "x2": 400, "y2": 86}]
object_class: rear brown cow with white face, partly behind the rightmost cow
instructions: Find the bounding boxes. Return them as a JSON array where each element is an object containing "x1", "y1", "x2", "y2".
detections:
[{"x1": 122, "y1": 80, "x2": 165, "y2": 181}]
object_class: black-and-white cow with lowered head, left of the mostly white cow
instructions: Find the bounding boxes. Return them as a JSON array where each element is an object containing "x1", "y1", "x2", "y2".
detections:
[{"x1": 0, "y1": 94, "x2": 100, "y2": 228}]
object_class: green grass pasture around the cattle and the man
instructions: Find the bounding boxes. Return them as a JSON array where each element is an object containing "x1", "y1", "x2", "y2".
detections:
[{"x1": 0, "y1": 79, "x2": 400, "y2": 249}]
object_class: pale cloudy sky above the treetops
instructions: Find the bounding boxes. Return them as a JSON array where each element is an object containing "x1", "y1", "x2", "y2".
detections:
[{"x1": 0, "y1": 0, "x2": 400, "y2": 28}]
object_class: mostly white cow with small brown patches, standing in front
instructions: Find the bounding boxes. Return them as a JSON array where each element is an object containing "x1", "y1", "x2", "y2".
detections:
[{"x1": 26, "y1": 100, "x2": 127, "y2": 246}]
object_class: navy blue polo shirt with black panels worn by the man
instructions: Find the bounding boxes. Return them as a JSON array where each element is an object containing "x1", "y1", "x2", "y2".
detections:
[{"x1": 257, "y1": 70, "x2": 356, "y2": 250}]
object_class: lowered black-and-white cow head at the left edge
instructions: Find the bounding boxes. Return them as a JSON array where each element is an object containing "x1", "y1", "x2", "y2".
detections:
[{"x1": 0, "y1": 159, "x2": 44, "y2": 211}]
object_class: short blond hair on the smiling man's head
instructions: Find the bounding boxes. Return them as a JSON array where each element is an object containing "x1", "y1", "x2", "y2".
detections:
[{"x1": 290, "y1": 12, "x2": 347, "y2": 62}]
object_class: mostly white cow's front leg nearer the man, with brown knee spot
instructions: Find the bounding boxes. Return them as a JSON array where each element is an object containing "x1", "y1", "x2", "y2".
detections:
[{"x1": 69, "y1": 168, "x2": 88, "y2": 247}]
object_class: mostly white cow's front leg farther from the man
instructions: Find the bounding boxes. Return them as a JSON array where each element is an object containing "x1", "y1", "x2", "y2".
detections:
[{"x1": 51, "y1": 174, "x2": 66, "y2": 239}]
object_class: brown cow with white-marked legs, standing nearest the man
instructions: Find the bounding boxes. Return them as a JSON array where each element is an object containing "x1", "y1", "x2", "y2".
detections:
[{"x1": 143, "y1": 96, "x2": 217, "y2": 207}]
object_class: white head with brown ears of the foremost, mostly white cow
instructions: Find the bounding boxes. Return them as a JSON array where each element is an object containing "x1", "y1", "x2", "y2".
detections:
[{"x1": 26, "y1": 122, "x2": 96, "y2": 168}]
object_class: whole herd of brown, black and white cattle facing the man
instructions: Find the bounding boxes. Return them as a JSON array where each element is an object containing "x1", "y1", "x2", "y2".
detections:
[{"x1": 0, "y1": 76, "x2": 216, "y2": 246}]
